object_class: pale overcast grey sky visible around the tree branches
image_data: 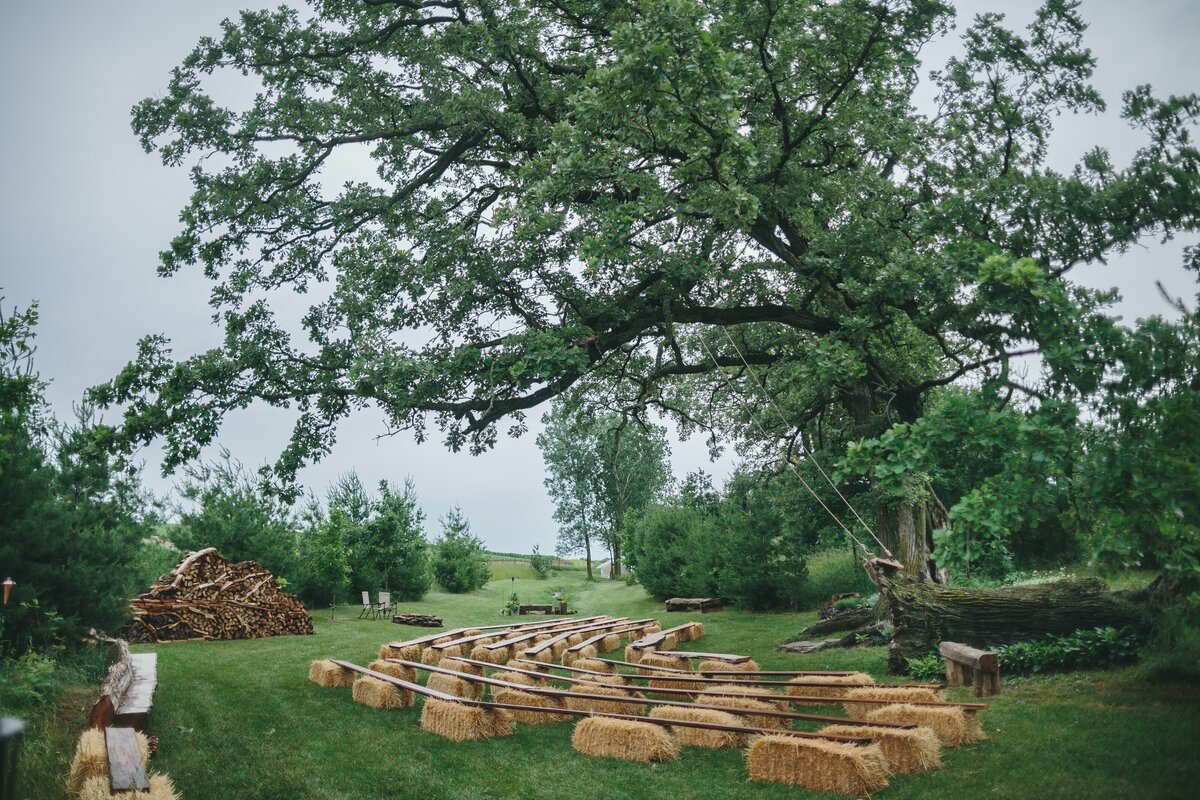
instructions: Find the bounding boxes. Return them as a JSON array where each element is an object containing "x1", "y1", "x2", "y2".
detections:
[{"x1": 0, "y1": 0, "x2": 1200, "y2": 552}]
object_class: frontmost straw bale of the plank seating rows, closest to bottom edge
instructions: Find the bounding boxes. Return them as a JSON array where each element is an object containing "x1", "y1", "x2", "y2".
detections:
[{"x1": 746, "y1": 735, "x2": 888, "y2": 798}]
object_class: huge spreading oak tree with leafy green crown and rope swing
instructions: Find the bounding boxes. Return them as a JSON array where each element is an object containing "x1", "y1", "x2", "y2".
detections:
[{"x1": 96, "y1": 0, "x2": 1200, "y2": 571}]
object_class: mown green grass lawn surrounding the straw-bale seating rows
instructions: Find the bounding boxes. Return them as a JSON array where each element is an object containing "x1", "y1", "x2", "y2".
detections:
[{"x1": 26, "y1": 572, "x2": 1200, "y2": 800}]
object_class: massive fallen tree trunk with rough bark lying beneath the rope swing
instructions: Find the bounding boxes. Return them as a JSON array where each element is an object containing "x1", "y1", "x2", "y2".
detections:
[{"x1": 876, "y1": 570, "x2": 1146, "y2": 673}]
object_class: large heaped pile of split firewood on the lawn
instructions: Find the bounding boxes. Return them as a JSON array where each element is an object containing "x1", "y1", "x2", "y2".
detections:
[{"x1": 122, "y1": 547, "x2": 312, "y2": 642}]
